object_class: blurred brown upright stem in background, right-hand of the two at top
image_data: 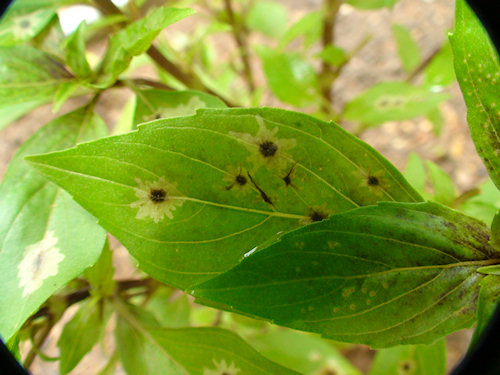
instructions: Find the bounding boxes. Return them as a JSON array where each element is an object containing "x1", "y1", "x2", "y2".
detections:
[{"x1": 319, "y1": 0, "x2": 343, "y2": 112}]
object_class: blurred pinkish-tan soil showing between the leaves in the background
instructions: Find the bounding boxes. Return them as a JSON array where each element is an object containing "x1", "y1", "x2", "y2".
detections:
[{"x1": 0, "y1": 0, "x2": 487, "y2": 375}]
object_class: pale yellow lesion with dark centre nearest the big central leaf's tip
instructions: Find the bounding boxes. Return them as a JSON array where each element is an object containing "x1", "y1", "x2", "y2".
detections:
[{"x1": 130, "y1": 177, "x2": 184, "y2": 223}]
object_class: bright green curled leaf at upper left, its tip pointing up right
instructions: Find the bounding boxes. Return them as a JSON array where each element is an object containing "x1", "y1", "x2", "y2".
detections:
[{"x1": 98, "y1": 7, "x2": 194, "y2": 87}]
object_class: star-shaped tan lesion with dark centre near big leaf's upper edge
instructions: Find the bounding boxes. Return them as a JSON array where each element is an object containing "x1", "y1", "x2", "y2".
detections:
[{"x1": 229, "y1": 116, "x2": 297, "y2": 172}]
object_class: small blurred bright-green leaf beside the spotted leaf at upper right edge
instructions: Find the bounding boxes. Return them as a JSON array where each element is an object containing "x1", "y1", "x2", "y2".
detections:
[{"x1": 422, "y1": 41, "x2": 456, "y2": 87}]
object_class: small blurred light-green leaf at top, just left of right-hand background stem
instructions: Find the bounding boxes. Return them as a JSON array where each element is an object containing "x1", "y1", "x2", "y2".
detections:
[{"x1": 279, "y1": 11, "x2": 323, "y2": 49}]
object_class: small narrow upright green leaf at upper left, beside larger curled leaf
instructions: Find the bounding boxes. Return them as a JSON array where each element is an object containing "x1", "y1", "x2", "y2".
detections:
[{"x1": 64, "y1": 21, "x2": 94, "y2": 79}]
